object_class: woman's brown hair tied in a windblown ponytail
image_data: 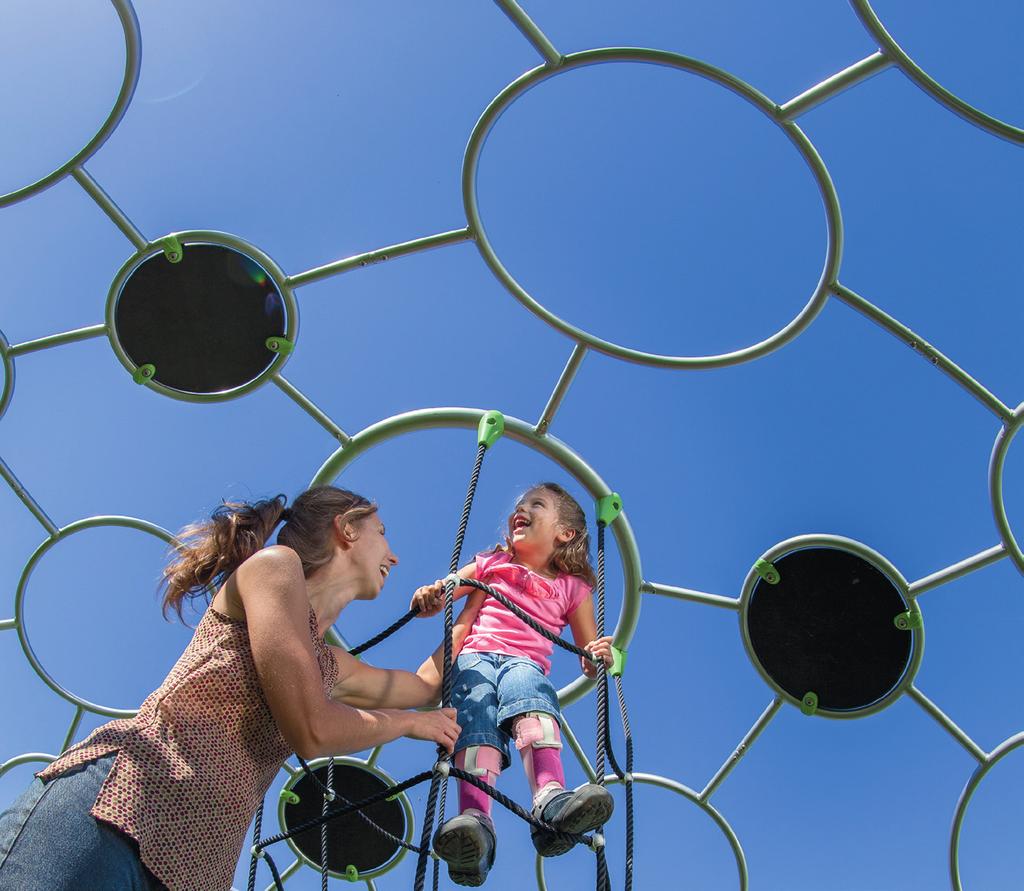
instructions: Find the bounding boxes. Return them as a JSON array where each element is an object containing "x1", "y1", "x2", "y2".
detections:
[{"x1": 162, "y1": 485, "x2": 377, "y2": 619}]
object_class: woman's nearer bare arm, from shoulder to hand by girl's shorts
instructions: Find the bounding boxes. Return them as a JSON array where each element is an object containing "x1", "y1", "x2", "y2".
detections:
[{"x1": 234, "y1": 546, "x2": 459, "y2": 758}]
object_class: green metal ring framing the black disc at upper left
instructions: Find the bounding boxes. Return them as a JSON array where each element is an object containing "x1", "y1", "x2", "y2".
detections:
[{"x1": 104, "y1": 229, "x2": 299, "y2": 402}]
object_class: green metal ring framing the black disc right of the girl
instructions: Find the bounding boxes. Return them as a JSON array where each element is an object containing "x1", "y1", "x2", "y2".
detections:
[{"x1": 739, "y1": 535, "x2": 925, "y2": 719}]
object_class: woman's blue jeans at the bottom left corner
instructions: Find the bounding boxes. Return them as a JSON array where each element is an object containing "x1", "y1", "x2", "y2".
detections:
[{"x1": 0, "y1": 755, "x2": 164, "y2": 891}]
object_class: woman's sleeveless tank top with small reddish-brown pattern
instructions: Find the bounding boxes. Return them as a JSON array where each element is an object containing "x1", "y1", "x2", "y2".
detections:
[{"x1": 36, "y1": 607, "x2": 338, "y2": 891}]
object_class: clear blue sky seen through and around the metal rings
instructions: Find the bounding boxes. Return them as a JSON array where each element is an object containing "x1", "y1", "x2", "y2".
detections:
[{"x1": 0, "y1": 0, "x2": 1024, "y2": 891}]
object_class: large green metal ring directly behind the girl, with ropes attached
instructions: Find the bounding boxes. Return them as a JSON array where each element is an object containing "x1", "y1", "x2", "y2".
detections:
[{"x1": 309, "y1": 409, "x2": 643, "y2": 706}]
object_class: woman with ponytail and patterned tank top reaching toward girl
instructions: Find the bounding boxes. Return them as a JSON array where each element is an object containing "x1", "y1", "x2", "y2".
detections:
[{"x1": 0, "y1": 486, "x2": 460, "y2": 891}]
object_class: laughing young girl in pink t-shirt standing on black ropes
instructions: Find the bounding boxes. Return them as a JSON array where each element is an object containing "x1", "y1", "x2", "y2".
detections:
[{"x1": 413, "y1": 482, "x2": 613, "y2": 886}]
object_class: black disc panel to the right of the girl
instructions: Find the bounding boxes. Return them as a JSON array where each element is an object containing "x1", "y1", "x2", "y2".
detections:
[{"x1": 746, "y1": 548, "x2": 912, "y2": 712}]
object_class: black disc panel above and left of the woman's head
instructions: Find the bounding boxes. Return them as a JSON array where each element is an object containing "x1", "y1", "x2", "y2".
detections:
[{"x1": 114, "y1": 244, "x2": 285, "y2": 393}]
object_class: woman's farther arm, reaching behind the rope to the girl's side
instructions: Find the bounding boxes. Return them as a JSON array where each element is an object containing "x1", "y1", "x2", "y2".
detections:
[{"x1": 331, "y1": 589, "x2": 486, "y2": 709}]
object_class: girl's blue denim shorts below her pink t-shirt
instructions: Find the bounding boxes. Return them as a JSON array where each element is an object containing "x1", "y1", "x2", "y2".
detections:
[{"x1": 452, "y1": 652, "x2": 561, "y2": 767}]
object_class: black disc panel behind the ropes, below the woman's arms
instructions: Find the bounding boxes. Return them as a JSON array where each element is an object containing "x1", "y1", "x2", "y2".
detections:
[{"x1": 285, "y1": 764, "x2": 406, "y2": 873}]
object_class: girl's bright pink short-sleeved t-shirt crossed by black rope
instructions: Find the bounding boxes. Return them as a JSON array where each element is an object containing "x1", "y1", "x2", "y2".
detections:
[{"x1": 462, "y1": 551, "x2": 591, "y2": 674}]
